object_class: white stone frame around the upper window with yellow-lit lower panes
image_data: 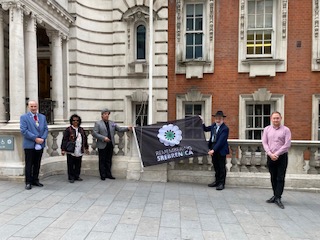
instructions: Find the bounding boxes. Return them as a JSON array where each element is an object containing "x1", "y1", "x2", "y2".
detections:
[{"x1": 238, "y1": 0, "x2": 288, "y2": 77}]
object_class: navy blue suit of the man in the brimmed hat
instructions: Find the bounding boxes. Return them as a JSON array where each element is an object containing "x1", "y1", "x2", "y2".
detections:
[{"x1": 203, "y1": 123, "x2": 229, "y2": 186}]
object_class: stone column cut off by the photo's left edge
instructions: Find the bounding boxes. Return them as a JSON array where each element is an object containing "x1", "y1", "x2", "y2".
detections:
[{"x1": 0, "y1": 9, "x2": 7, "y2": 124}]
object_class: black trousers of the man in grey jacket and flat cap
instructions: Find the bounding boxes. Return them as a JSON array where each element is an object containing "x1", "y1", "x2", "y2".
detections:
[{"x1": 98, "y1": 142, "x2": 113, "y2": 178}]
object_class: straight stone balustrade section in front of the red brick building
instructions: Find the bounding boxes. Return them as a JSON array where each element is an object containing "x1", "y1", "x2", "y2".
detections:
[{"x1": 170, "y1": 139, "x2": 320, "y2": 174}]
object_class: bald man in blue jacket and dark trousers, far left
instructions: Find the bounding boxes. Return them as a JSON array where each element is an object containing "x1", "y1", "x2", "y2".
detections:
[{"x1": 20, "y1": 101, "x2": 48, "y2": 190}]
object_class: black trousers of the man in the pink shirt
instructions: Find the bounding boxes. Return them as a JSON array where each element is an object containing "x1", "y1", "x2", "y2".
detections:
[{"x1": 267, "y1": 153, "x2": 288, "y2": 198}]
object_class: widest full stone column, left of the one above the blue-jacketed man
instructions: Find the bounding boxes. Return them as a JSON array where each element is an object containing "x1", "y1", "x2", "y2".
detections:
[{"x1": 2, "y1": 2, "x2": 26, "y2": 124}]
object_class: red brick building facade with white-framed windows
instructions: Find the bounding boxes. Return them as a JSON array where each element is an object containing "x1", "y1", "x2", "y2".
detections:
[{"x1": 168, "y1": 0, "x2": 320, "y2": 140}]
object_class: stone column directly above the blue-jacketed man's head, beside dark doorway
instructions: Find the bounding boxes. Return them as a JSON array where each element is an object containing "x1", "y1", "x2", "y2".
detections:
[{"x1": 25, "y1": 14, "x2": 39, "y2": 102}]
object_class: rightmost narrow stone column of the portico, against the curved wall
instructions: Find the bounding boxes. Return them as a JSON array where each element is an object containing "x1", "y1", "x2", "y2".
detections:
[{"x1": 62, "y1": 37, "x2": 70, "y2": 122}]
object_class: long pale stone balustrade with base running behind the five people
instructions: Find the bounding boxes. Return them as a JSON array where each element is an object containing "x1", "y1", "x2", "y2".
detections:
[{"x1": 0, "y1": 124, "x2": 320, "y2": 190}]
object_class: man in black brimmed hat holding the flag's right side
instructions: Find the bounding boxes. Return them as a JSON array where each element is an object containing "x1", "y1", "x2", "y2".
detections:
[{"x1": 203, "y1": 111, "x2": 229, "y2": 190}]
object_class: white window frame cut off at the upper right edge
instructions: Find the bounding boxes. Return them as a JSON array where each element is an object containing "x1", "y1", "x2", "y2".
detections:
[{"x1": 311, "y1": 0, "x2": 320, "y2": 71}]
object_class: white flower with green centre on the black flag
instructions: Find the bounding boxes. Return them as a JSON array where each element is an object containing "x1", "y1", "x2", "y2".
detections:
[{"x1": 158, "y1": 124, "x2": 182, "y2": 147}]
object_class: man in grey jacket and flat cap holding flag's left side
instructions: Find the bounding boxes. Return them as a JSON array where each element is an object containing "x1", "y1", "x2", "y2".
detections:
[{"x1": 92, "y1": 109, "x2": 132, "y2": 181}]
